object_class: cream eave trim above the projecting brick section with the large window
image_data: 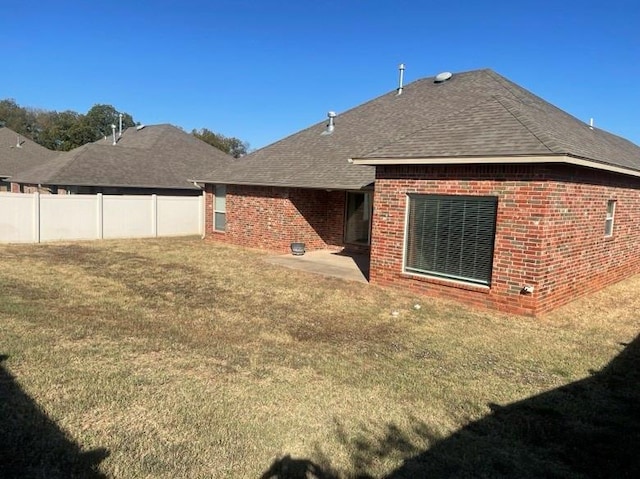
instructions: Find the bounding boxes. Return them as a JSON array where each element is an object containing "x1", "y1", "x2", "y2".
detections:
[{"x1": 349, "y1": 154, "x2": 640, "y2": 177}]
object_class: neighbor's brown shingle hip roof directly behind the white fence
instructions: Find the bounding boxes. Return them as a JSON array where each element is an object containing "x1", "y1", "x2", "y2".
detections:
[{"x1": 12, "y1": 124, "x2": 234, "y2": 189}]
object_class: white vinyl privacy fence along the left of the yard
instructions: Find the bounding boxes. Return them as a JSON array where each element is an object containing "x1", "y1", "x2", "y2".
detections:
[{"x1": 0, "y1": 193, "x2": 204, "y2": 243}]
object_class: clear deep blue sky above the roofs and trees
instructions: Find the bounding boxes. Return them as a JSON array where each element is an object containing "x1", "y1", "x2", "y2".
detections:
[{"x1": 0, "y1": 0, "x2": 640, "y2": 148}]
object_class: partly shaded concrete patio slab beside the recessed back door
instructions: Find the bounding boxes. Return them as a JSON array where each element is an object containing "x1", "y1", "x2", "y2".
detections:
[{"x1": 266, "y1": 250, "x2": 369, "y2": 283}]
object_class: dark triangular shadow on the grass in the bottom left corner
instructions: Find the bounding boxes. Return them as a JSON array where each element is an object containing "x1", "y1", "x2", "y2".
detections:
[{"x1": 0, "y1": 355, "x2": 109, "y2": 479}]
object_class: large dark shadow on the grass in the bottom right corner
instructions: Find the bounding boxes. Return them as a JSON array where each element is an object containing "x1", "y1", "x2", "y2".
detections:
[{"x1": 265, "y1": 336, "x2": 640, "y2": 479}]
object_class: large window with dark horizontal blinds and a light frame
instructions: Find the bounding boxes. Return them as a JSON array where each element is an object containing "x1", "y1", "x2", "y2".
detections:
[{"x1": 405, "y1": 195, "x2": 498, "y2": 285}]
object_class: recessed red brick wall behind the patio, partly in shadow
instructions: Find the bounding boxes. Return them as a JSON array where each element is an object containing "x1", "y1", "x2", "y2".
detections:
[{"x1": 205, "y1": 185, "x2": 345, "y2": 253}]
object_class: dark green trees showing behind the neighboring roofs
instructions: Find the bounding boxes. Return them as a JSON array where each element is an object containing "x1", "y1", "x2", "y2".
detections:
[{"x1": 0, "y1": 99, "x2": 249, "y2": 158}]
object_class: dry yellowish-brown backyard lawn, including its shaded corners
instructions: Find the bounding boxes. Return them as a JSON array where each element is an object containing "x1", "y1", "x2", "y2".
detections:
[{"x1": 0, "y1": 238, "x2": 640, "y2": 478}]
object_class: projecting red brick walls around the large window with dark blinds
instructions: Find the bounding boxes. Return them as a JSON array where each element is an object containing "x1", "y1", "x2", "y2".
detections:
[{"x1": 371, "y1": 165, "x2": 640, "y2": 314}]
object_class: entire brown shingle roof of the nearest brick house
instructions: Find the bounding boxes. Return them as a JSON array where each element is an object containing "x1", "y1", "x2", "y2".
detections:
[{"x1": 198, "y1": 69, "x2": 640, "y2": 189}]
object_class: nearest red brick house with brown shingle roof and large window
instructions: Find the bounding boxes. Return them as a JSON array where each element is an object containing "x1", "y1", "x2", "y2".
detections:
[{"x1": 199, "y1": 70, "x2": 640, "y2": 315}]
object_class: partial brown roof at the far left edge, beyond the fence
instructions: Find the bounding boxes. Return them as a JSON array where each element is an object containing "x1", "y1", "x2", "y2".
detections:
[{"x1": 0, "y1": 127, "x2": 57, "y2": 178}]
